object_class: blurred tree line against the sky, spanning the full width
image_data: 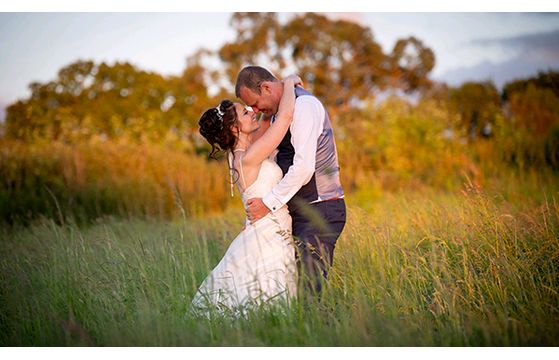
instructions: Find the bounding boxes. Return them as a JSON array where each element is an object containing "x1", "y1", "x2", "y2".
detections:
[{"x1": 2, "y1": 13, "x2": 559, "y2": 157}]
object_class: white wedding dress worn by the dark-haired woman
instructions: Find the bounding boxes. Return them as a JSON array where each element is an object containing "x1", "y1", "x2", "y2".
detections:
[{"x1": 191, "y1": 153, "x2": 297, "y2": 315}]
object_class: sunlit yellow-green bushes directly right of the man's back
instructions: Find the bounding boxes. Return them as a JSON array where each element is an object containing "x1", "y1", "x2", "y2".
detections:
[{"x1": 336, "y1": 97, "x2": 476, "y2": 191}]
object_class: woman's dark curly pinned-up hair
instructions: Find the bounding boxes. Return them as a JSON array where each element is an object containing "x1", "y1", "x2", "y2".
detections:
[{"x1": 198, "y1": 99, "x2": 237, "y2": 159}]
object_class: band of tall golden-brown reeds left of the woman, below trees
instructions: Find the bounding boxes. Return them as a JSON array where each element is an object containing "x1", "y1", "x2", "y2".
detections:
[{"x1": 0, "y1": 140, "x2": 234, "y2": 223}]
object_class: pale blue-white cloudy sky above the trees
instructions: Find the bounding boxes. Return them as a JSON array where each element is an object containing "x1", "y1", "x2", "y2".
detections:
[{"x1": 0, "y1": 12, "x2": 559, "y2": 119}]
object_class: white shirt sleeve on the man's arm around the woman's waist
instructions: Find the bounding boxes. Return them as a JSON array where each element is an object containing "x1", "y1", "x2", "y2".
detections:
[{"x1": 262, "y1": 95, "x2": 325, "y2": 212}]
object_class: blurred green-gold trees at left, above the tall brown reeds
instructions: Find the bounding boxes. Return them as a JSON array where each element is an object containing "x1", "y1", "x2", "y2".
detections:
[{"x1": 5, "y1": 61, "x2": 218, "y2": 148}]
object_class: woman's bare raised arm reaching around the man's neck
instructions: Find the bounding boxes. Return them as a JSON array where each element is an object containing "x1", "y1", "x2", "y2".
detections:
[{"x1": 243, "y1": 75, "x2": 301, "y2": 165}]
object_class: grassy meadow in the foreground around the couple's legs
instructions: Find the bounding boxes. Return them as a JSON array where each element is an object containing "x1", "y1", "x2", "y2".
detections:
[{"x1": 0, "y1": 169, "x2": 559, "y2": 346}]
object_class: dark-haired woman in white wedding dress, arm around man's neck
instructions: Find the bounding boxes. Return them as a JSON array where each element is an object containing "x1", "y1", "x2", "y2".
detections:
[{"x1": 191, "y1": 75, "x2": 301, "y2": 314}]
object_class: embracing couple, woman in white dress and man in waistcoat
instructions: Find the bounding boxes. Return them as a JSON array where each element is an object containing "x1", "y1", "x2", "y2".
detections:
[{"x1": 191, "y1": 66, "x2": 346, "y2": 314}]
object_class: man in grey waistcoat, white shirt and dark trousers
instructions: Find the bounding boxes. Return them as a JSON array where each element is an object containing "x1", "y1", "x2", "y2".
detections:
[{"x1": 235, "y1": 66, "x2": 346, "y2": 294}]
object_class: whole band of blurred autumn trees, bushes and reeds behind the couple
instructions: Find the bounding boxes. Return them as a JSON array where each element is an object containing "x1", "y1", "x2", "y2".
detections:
[{"x1": 0, "y1": 13, "x2": 559, "y2": 222}]
